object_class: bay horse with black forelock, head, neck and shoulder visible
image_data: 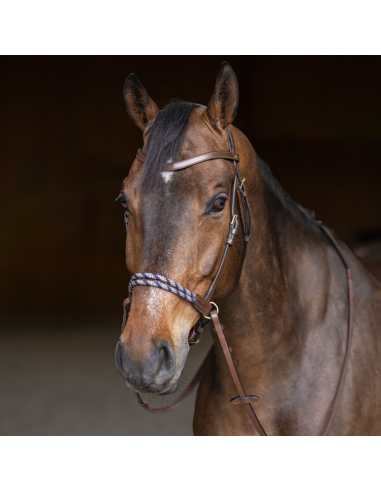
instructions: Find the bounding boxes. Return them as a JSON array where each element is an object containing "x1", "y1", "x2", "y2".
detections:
[{"x1": 116, "y1": 62, "x2": 381, "y2": 435}]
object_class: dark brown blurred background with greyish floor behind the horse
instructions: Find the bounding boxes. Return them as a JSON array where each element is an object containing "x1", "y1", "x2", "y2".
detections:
[{"x1": 0, "y1": 56, "x2": 381, "y2": 435}]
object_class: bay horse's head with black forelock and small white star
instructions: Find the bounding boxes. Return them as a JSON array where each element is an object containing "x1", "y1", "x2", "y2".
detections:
[{"x1": 116, "y1": 63, "x2": 249, "y2": 394}]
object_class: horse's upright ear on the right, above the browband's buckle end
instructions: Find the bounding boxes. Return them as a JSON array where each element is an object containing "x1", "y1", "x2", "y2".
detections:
[{"x1": 207, "y1": 62, "x2": 238, "y2": 130}]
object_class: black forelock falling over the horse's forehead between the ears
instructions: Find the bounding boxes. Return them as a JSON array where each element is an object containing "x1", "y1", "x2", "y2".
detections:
[{"x1": 142, "y1": 100, "x2": 198, "y2": 189}]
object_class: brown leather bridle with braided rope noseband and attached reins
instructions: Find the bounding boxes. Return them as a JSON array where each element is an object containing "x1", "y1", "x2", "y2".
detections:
[{"x1": 122, "y1": 130, "x2": 353, "y2": 436}]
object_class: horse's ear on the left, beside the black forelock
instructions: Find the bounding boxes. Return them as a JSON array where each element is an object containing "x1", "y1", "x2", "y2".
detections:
[{"x1": 123, "y1": 73, "x2": 159, "y2": 131}]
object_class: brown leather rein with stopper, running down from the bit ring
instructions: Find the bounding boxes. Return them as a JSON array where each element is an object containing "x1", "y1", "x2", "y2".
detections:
[{"x1": 210, "y1": 311, "x2": 267, "y2": 436}]
